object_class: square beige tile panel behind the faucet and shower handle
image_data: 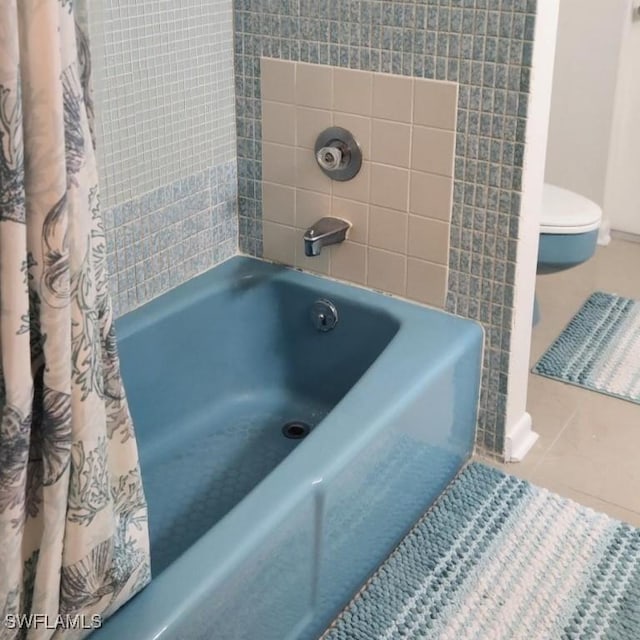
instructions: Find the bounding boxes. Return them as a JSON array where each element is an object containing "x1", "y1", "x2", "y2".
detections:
[{"x1": 261, "y1": 58, "x2": 458, "y2": 308}]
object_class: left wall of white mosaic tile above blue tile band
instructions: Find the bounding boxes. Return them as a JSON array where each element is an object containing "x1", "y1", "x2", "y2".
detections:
[{"x1": 89, "y1": 0, "x2": 238, "y2": 315}]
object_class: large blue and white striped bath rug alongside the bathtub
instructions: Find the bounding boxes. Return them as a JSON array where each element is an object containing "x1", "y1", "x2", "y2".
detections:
[{"x1": 322, "y1": 463, "x2": 640, "y2": 640}]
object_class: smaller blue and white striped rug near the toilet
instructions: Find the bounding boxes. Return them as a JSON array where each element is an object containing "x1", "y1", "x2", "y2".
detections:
[{"x1": 532, "y1": 292, "x2": 640, "y2": 404}]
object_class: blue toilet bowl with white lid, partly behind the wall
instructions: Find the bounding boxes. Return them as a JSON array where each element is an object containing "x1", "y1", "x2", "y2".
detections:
[{"x1": 538, "y1": 184, "x2": 602, "y2": 273}]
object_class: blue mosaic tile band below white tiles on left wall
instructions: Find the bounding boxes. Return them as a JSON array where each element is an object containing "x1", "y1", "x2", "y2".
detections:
[{"x1": 104, "y1": 161, "x2": 238, "y2": 316}]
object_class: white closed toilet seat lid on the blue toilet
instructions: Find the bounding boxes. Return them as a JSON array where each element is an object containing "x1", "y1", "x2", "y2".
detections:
[{"x1": 540, "y1": 183, "x2": 602, "y2": 234}]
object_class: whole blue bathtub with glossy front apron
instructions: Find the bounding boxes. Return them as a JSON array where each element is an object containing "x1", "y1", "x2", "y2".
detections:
[{"x1": 94, "y1": 257, "x2": 482, "y2": 640}]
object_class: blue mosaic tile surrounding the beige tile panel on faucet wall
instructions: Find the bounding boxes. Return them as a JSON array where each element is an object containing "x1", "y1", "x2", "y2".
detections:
[{"x1": 234, "y1": 0, "x2": 537, "y2": 453}]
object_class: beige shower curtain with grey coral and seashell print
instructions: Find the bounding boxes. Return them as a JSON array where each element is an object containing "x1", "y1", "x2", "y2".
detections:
[{"x1": 0, "y1": 0, "x2": 150, "y2": 640}]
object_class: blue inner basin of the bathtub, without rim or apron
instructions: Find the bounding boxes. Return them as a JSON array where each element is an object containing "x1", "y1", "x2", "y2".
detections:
[{"x1": 119, "y1": 274, "x2": 399, "y2": 575}]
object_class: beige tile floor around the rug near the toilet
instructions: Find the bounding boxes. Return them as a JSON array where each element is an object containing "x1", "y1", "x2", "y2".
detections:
[{"x1": 478, "y1": 240, "x2": 640, "y2": 527}]
